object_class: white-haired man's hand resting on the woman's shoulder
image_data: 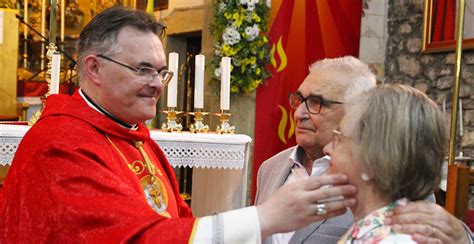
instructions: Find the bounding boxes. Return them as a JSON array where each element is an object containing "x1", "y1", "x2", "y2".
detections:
[{"x1": 385, "y1": 201, "x2": 470, "y2": 243}]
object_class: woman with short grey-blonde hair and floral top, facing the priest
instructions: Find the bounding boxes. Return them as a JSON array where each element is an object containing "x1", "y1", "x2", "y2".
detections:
[{"x1": 324, "y1": 85, "x2": 448, "y2": 243}]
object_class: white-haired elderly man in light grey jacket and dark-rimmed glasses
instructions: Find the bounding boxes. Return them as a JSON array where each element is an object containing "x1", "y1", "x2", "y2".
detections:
[{"x1": 255, "y1": 56, "x2": 469, "y2": 243}]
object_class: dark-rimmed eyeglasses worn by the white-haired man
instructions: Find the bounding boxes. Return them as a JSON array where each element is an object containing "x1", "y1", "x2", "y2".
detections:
[{"x1": 288, "y1": 92, "x2": 343, "y2": 114}]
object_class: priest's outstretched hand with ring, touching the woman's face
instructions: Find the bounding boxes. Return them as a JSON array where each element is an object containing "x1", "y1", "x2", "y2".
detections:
[{"x1": 257, "y1": 174, "x2": 356, "y2": 238}]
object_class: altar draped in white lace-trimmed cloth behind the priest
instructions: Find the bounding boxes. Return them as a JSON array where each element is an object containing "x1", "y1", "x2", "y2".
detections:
[{"x1": 0, "y1": 124, "x2": 252, "y2": 217}]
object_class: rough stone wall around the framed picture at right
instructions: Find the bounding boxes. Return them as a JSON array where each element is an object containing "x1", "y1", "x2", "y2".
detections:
[{"x1": 384, "y1": 0, "x2": 474, "y2": 157}]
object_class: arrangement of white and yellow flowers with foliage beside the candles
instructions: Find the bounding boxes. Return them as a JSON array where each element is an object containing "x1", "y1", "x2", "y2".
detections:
[{"x1": 211, "y1": 0, "x2": 270, "y2": 93}]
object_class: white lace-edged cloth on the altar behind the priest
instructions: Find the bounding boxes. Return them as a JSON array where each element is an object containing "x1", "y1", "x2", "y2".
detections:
[{"x1": 0, "y1": 124, "x2": 252, "y2": 169}]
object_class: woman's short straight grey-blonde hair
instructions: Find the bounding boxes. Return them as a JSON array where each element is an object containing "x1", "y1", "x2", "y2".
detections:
[{"x1": 346, "y1": 84, "x2": 448, "y2": 200}]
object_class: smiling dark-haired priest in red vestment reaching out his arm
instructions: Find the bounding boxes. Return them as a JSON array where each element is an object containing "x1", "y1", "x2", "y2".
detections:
[{"x1": 0, "y1": 7, "x2": 355, "y2": 243}]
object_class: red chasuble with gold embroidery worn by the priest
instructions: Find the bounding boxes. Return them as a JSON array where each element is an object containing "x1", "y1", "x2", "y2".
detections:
[{"x1": 0, "y1": 93, "x2": 195, "y2": 243}]
